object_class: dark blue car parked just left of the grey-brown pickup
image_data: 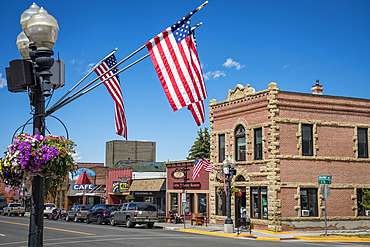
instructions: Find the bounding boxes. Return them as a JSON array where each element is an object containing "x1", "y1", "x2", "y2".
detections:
[{"x1": 86, "y1": 204, "x2": 119, "y2": 225}]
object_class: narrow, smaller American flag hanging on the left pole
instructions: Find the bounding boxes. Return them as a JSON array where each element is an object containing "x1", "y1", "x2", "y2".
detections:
[{"x1": 95, "y1": 54, "x2": 127, "y2": 140}]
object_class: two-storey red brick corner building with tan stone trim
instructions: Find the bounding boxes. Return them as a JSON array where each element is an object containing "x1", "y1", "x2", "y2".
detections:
[{"x1": 209, "y1": 81, "x2": 370, "y2": 232}]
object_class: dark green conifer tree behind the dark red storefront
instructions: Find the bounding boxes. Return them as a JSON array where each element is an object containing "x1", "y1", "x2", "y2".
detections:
[{"x1": 186, "y1": 128, "x2": 210, "y2": 160}]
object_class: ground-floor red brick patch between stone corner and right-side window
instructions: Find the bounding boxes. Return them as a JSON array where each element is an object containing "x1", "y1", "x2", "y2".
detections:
[{"x1": 278, "y1": 188, "x2": 298, "y2": 217}]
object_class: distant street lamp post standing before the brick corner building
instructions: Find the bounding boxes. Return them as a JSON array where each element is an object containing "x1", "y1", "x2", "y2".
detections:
[{"x1": 223, "y1": 157, "x2": 235, "y2": 233}]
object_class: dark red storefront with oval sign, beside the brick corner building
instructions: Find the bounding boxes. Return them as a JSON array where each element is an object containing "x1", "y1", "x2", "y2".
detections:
[{"x1": 166, "y1": 160, "x2": 209, "y2": 222}]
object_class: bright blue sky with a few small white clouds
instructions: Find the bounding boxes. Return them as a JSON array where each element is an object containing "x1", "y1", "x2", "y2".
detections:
[{"x1": 0, "y1": 0, "x2": 370, "y2": 162}]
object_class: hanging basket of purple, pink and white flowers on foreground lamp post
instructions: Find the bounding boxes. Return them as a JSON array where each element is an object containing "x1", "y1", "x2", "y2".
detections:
[{"x1": 0, "y1": 133, "x2": 75, "y2": 187}]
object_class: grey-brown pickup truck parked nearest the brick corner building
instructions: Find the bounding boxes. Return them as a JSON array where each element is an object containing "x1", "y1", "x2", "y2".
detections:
[{"x1": 110, "y1": 202, "x2": 158, "y2": 228}]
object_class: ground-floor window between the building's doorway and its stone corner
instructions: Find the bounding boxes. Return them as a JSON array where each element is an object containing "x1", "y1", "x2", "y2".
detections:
[{"x1": 251, "y1": 187, "x2": 268, "y2": 219}]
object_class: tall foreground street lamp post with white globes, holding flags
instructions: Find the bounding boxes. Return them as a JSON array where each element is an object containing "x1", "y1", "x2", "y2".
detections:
[{"x1": 15, "y1": 3, "x2": 59, "y2": 247}]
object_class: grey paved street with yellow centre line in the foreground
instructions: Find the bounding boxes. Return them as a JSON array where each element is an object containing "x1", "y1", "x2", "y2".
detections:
[{"x1": 0, "y1": 216, "x2": 370, "y2": 247}]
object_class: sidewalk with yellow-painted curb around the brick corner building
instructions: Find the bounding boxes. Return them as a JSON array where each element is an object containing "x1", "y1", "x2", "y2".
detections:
[{"x1": 155, "y1": 222, "x2": 370, "y2": 242}]
